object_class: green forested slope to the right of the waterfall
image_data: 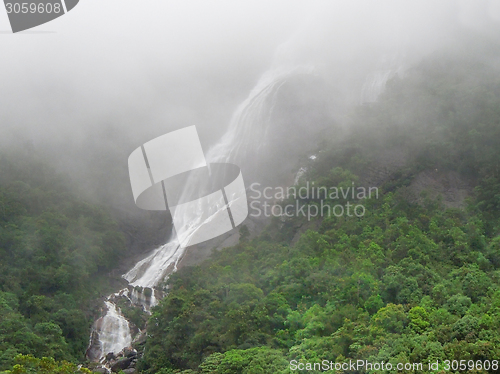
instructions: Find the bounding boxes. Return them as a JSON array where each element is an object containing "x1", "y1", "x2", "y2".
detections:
[{"x1": 140, "y1": 56, "x2": 500, "y2": 374}]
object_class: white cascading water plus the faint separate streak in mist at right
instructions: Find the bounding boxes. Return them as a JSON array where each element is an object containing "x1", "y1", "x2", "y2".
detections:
[{"x1": 89, "y1": 2, "x2": 410, "y2": 358}]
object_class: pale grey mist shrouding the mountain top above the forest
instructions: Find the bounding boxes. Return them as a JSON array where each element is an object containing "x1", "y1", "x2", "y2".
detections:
[{"x1": 0, "y1": 0, "x2": 500, "y2": 210}]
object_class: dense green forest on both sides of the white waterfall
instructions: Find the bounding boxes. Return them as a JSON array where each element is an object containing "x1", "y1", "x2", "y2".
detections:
[{"x1": 0, "y1": 54, "x2": 500, "y2": 374}]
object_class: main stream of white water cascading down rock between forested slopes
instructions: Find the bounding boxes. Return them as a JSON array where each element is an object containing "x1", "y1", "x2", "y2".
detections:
[{"x1": 91, "y1": 67, "x2": 312, "y2": 358}]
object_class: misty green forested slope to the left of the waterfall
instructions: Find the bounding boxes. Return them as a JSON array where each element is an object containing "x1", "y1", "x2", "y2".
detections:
[{"x1": 0, "y1": 152, "x2": 125, "y2": 372}]
